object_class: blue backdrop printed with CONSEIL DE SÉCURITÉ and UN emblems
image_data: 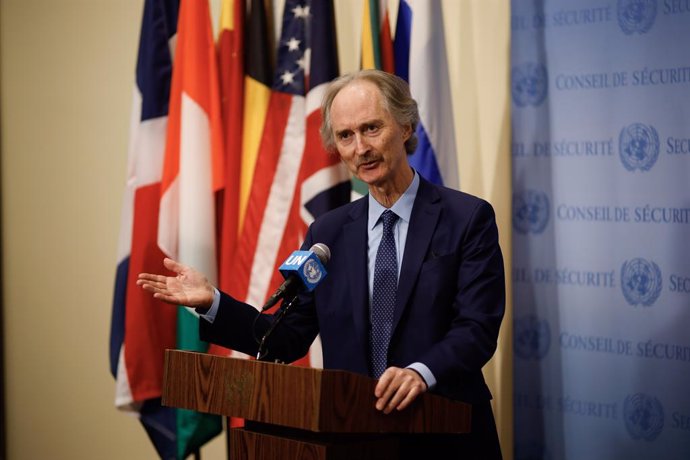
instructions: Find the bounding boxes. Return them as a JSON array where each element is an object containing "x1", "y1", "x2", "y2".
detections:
[{"x1": 511, "y1": 0, "x2": 690, "y2": 460}]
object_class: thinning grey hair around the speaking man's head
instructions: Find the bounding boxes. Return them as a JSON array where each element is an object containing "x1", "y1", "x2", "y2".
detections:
[{"x1": 320, "y1": 69, "x2": 419, "y2": 155}]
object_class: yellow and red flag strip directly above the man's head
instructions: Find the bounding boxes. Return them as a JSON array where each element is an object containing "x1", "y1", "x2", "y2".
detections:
[{"x1": 361, "y1": 0, "x2": 395, "y2": 73}]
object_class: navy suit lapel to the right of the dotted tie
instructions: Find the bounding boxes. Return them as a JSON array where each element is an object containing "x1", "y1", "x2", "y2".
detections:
[{"x1": 393, "y1": 177, "x2": 441, "y2": 332}]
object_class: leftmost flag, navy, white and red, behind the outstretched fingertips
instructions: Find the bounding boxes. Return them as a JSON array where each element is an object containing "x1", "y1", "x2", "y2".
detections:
[{"x1": 110, "y1": 0, "x2": 192, "y2": 458}]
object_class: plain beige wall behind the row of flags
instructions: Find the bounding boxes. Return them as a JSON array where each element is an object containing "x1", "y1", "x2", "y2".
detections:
[{"x1": 0, "y1": 0, "x2": 509, "y2": 460}]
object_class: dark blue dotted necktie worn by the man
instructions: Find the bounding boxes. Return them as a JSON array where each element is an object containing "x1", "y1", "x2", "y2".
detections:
[{"x1": 370, "y1": 209, "x2": 398, "y2": 378}]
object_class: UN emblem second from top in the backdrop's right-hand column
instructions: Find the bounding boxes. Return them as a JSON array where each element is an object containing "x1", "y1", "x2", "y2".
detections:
[{"x1": 618, "y1": 123, "x2": 659, "y2": 171}]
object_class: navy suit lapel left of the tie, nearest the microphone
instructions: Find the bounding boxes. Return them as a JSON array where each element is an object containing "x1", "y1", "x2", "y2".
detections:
[{"x1": 343, "y1": 196, "x2": 369, "y2": 349}]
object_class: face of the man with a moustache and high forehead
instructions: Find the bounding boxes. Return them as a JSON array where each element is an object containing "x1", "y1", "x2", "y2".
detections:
[{"x1": 331, "y1": 80, "x2": 412, "y2": 187}]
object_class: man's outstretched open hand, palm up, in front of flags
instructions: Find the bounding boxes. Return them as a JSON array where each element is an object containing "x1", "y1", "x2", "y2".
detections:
[{"x1": 137, "y1": 258, "x2": 213, "y2": 308}]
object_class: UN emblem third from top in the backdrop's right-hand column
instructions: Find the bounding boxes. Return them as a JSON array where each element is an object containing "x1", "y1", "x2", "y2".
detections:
[{"x1": 621, "y1": 258, "x2": 661, "y2": 307}]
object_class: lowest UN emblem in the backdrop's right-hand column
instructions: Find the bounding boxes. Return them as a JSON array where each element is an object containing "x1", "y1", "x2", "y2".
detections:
[{"x1": 623, "y1": 393, "x2": 664, "y2": 441}]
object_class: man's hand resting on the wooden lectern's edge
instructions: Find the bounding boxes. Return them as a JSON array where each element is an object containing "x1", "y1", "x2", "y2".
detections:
[{"x1": 374, "y1": 367, "x2": 427, "y2": 414}]
